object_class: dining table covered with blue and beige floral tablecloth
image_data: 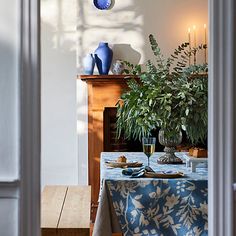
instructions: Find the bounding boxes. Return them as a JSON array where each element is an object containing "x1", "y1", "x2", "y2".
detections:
[{"x1": 93, "y1": 152, "x2": 208, "y2": 236}]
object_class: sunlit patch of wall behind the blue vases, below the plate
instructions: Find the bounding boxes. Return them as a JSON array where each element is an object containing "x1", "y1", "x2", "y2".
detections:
[{"x1": 77, "y1": 0, "x2": 144, "y2": 73}]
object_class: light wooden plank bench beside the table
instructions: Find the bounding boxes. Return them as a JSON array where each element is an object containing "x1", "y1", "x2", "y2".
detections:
[{"x1": 41, "y1": 186, "x2": 91, "y2": 236}]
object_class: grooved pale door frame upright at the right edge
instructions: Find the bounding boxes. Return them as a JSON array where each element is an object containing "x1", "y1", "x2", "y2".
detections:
[{"x1": 208, "y1": 0, "x2": 236, "y2": 236}]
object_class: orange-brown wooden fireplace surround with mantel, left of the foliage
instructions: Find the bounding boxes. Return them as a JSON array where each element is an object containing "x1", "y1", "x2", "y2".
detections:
[{"x1": 78, "y1": 75, "x2": 130, "y2": 220}]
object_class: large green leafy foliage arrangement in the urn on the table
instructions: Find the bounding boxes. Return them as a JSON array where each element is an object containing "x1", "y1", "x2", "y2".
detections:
[{"x1": 117, "y1": 35, "x2": 208, "y2": 144}]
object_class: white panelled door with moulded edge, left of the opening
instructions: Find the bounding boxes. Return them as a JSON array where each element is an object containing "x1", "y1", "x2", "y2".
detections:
[{"x1": 0, "y1": 0, "x2": 40, "y2": 236}]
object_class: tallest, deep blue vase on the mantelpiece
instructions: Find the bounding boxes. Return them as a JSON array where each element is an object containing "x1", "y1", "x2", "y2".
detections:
[{"x1": 94, "y1": 43, "x2": 113, "y2": 75}]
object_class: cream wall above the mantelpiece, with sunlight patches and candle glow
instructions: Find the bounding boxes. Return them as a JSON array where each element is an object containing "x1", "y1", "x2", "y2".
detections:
[{"x1": 76, "y1": 0, "x2": 207, "y2": 73}]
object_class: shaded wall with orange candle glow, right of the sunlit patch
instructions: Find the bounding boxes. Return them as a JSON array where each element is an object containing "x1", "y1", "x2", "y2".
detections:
[{"x1": 131, "y1": 0, "x2": 208, "y2": 63}]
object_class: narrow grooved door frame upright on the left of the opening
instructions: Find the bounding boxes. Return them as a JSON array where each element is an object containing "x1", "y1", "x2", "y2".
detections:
[{"x1": 19, "y1": 0, "x2": 41, "y2": 236}]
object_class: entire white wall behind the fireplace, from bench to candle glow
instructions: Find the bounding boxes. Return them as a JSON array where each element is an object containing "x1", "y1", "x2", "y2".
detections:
[{"x1": 42, "y1": 0, "x2": 208, "y2": 184}]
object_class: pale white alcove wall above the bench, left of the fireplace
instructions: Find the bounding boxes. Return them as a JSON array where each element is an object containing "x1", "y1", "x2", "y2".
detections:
[{"x1": 41, "y1": 0, "x2": 78, "y2": 186}]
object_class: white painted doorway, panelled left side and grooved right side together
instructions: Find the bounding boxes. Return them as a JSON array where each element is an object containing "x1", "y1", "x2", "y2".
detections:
[{"x1": 0, "y1": 0, "x2": 236, "y2": 236}]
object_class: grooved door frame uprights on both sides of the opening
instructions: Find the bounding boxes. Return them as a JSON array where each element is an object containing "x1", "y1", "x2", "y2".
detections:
[{"x1": 20, "y1": 0, "x2": 236, "y2": 236}]
